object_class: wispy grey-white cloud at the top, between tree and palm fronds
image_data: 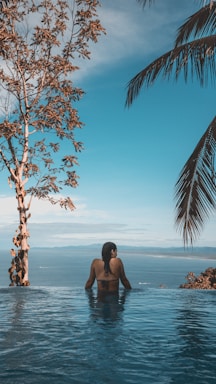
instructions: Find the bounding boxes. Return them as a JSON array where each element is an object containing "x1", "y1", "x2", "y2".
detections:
[{"x1": 75, "y1": 0, "x2": 197, "y2": 80}]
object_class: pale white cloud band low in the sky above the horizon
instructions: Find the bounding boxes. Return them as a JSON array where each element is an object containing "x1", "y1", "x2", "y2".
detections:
[{"x1": 0, "y1": 192, "x2": 216, "y2": 249}]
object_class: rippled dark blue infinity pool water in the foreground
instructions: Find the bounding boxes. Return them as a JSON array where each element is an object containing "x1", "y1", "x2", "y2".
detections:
[{"x1": 0, "y1": 286, "x2": 216, "y2": 384}]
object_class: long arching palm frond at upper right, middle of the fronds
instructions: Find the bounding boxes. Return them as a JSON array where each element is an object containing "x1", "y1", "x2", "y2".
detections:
[{"x1": 125, "y1": 35, "x2": 216, "y2": 107}]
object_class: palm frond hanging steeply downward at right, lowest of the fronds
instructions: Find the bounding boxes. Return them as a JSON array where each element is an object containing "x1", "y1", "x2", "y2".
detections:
[{"x1": 175, "y1": 117, "x2": 216, "y2": 245}]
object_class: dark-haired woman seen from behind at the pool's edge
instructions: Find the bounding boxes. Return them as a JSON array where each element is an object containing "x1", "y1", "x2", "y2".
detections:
[{"x1": 85, "y1": 242, "x2": 131, "y2": 292}]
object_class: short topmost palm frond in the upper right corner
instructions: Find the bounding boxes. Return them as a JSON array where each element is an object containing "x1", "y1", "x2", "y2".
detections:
[{"x1": 175, "y1": 2, "x2": 216, "y2": 46}]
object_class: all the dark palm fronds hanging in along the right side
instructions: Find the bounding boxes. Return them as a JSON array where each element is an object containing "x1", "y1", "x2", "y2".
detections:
[{"x1": 126, "y1": 0, "x2": 216, "y2": 244}]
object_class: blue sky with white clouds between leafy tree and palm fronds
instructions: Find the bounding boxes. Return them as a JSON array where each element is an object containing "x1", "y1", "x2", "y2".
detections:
[{"x1": 0, "y1": 0, "x2": 216, "y2": 248}]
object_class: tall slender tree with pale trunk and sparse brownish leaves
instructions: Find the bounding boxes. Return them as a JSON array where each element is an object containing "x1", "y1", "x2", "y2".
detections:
[{"x1": 0, "y1": 0, "x2": 104, "y2": 285}]
